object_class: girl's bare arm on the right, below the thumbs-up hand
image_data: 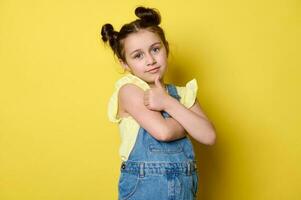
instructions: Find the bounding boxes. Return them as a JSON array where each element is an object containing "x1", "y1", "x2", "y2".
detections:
[{"x1": 164, "y1": 98, "x2": 216, "y2": 145}]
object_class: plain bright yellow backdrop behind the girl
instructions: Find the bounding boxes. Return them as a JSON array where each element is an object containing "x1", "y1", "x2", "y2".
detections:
[{"x1": 0, "y1": 0, "x2": 301, "y2": 200}]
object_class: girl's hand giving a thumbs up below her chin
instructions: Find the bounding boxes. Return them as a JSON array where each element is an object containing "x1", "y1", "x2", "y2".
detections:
[{"x1": 144, "y1": 75, "x2": 170, "y2": 111}]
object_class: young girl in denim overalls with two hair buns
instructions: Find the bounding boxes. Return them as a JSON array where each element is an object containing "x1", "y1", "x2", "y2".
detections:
[{"x1": 101, "y1": 7, "x2": 215, "y2": 200}]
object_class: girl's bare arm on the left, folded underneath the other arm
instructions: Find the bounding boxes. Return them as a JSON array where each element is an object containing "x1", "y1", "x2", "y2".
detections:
[{"x1": 119, "y1": 84, "x2": 186, "y2": 141}]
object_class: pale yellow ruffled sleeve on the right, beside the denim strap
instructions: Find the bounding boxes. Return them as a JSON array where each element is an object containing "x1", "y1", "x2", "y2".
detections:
[{"x1": 178, "y1": 79, "x2": 198, "y2": 108}]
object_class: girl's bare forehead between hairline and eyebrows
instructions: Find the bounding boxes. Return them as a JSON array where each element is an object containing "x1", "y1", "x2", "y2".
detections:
[{"x1": 124, "y1": 30, "x2": 161, "y2": 51}]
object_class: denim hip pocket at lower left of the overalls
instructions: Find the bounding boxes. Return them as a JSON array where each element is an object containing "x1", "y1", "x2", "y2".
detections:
[{"x1": 118, "y1": 173, "x2": 139, "y2": 200}]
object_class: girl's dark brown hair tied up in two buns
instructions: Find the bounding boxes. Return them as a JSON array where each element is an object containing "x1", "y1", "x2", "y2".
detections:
[{"x1": 101, "y1": 6, "x2": 169, "y2": 62}]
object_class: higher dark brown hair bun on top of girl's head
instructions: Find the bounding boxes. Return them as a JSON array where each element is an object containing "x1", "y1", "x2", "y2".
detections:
[{"x1": 135, "y1": 6, "x2": 161, "y2": 25}]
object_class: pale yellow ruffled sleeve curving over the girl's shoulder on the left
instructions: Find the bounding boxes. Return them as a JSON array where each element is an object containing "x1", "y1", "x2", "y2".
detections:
[{"x1": 107, "y1": 74, "x2": 149, "y2": 123}]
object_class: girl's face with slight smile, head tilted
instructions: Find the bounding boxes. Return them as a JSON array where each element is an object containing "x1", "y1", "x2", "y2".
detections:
[{"x1": 122, "y1": 30, "x2": 167, "y2": 83}]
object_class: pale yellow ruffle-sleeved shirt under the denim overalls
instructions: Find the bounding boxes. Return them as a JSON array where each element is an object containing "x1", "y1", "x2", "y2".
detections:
[{"x1": 108, "y1": 74, "x2": 198, "y2": 161}]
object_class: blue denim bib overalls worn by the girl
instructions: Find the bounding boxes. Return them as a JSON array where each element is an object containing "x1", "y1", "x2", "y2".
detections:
[{"x1": 118, "y1": 84, "x2": 198, "y2": 200}]
